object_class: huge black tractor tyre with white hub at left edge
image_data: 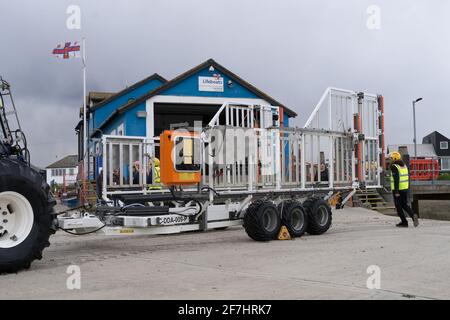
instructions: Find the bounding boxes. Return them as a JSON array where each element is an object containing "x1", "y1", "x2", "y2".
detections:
[{"x1": 0, "y1": 159, "x2": 56, "y2": 274}]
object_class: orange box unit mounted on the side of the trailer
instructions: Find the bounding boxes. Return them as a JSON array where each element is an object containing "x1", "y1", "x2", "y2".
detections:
[{"x1": 159, "y1": 130, "x2": 201, "y2": 186}]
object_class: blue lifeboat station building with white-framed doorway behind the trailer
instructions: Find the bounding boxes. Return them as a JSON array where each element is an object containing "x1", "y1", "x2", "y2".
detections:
[{"x1": 76, "y1": 59, "x2": 296, "y2": 178}]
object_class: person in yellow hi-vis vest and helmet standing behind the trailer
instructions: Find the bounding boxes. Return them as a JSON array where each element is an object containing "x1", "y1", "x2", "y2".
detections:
[{"x1": 389, "y1": 151, "x2": 419, "y2": 227}]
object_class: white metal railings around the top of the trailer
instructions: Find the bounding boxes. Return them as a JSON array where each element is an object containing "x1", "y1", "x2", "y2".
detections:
[{"x1": 97, "y1": 88, "x2": 381, "y2": 197}]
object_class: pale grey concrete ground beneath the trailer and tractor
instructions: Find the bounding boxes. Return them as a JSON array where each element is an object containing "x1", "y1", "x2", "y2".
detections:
[{"x1": 0, "y1": 208, "x2": 450, "y2": 299}]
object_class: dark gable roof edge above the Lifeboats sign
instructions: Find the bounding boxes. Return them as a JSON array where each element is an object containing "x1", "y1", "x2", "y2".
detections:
[{"x1": 98, "y1": 59, "x2": 297, "y2": 129}]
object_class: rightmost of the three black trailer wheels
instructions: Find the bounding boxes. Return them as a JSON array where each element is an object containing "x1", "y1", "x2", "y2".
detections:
[{"x1": 303, "y1": 197, "x2": 332, "y2": 235}]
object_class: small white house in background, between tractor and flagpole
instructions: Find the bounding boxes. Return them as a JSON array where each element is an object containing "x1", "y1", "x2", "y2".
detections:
[{"x1": 45, "y1": 155, "x2": 78, "y2": 185}]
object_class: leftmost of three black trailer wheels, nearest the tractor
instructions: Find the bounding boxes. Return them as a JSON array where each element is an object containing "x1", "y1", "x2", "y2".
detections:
[{"x1": 244, "y1": 200, "x2": 281, "y2": 241}]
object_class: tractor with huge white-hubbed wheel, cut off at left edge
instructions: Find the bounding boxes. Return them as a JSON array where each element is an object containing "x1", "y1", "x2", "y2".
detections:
[{"x1": 0, "y1": 77, "x2": 56, "y2": 273}]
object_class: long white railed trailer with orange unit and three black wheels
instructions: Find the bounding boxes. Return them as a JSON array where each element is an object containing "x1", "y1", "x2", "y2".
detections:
[{"x1": 0, "y1": 88, "x2": 384, "y2": 271}]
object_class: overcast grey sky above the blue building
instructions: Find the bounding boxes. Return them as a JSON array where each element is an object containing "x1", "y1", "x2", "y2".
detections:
[{"x1": 0, "y1": 0, "x2": 450, "y2": 167}]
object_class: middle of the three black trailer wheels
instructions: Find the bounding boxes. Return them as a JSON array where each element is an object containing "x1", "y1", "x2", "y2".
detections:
[{"x1": 279, "y1": 201, "x2": 308, "y2": 238}]
